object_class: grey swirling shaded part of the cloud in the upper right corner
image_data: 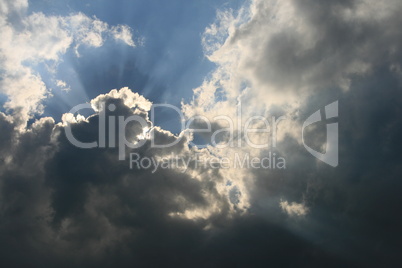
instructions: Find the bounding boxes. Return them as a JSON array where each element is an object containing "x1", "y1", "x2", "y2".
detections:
[{"x1": 228, "y1": 1, "x2": 402, "y2": 93}]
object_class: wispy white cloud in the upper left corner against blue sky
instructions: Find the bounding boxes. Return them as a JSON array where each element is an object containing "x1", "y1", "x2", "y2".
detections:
[{"x1": 0, "y1": 1, "x2": 134, "y2": 128}]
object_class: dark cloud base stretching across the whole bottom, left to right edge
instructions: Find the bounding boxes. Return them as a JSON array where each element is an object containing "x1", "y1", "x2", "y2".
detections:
[{"x1": 0, "y1": 72, "x2": 402, "y2": 267}]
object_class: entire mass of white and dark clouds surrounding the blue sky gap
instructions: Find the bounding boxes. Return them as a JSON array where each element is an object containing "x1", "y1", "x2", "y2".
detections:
[{"x1": 0, "y1": 0, "x2": 402, "y2": 267}]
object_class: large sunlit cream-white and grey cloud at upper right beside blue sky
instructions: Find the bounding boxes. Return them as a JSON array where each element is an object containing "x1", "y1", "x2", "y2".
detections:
[{"x1": 183, "y1": 0, "x2": 402, "y2": 164}]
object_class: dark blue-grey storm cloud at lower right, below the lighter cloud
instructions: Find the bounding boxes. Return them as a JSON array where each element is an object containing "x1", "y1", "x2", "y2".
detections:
[{"x1": 251, "y1": 68, "x2": 402, "y2": 267}]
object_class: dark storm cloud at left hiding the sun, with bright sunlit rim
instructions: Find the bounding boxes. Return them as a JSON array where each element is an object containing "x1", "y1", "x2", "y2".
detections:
[{"x1": 0, "y1": 89, "x2": 354, "y2": 267}]
